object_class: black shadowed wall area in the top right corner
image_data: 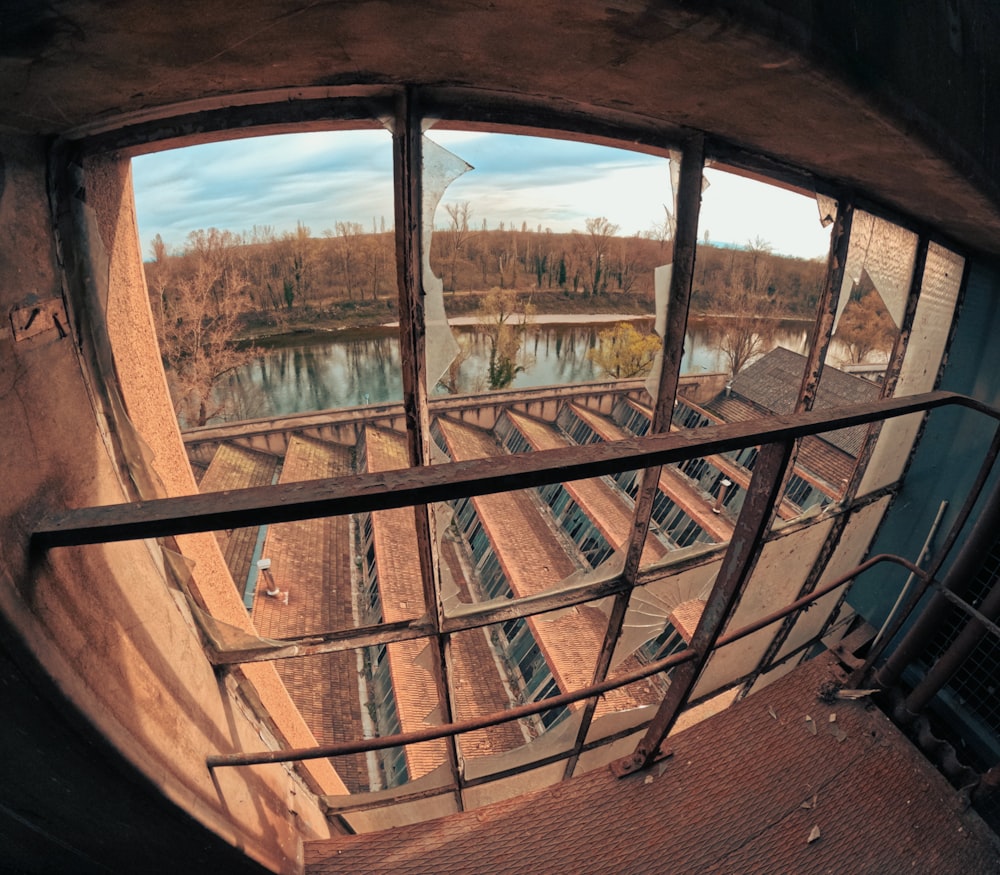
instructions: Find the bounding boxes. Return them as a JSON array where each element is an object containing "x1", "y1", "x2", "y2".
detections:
[{"x1": 722, "y1": 0, "x2": 1000, "y2": 216}]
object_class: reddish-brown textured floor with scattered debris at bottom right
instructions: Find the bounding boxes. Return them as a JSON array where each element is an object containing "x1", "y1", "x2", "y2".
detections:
[{"x1": 305, "y1": 656, "x2": 1000, "y2": 875}]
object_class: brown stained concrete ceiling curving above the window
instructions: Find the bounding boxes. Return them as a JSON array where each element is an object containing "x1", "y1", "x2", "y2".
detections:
[{"x1": 0, "y1": 0, "x2": 1000, "y2": 253}]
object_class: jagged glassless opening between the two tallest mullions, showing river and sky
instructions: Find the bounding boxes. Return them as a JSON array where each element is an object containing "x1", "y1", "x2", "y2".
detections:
[{"x1": 430, "y1": 125, "x2": 674, "y2": 404}]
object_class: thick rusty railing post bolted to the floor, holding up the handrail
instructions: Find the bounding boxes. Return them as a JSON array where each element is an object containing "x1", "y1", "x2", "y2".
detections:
[{"x1": 612, "y1": 441, "x2": 792, "y2": 776}]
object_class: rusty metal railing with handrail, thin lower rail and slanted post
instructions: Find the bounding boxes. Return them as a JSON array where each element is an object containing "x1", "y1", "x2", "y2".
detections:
[{"x1": 31, "y1": 392, "x2": 1000, "y2": 788}]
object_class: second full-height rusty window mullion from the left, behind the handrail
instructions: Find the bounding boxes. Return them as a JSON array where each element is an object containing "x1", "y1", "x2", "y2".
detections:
[{"x1": 564, "y1": 135, "x2": 705, "y2": 778}]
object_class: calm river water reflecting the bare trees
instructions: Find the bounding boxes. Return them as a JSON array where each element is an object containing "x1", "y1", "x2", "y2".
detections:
[{"x1": 211, "y1": 323, "x2": 807, "y2": 420}]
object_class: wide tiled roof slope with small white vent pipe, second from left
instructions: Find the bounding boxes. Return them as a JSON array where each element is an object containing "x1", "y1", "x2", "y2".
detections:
[{"x1": 253, "y1": 436, "x2": 368, "y2": 791}]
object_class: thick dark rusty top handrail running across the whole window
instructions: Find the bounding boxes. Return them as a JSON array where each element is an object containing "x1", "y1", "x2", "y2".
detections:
[{"x1": 31, "y1": 392, "x2": 976, "y2": 550}]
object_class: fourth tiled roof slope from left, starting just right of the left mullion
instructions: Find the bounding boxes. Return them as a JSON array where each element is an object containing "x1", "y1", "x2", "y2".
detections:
[{"x1": 438, "y1": 417, "x2": 655, "y2": 714}]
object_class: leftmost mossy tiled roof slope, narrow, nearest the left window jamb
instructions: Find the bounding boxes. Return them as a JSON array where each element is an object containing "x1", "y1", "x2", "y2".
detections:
[{"x1": 198, "y1": 443, "x2": 278, "y2": 595}]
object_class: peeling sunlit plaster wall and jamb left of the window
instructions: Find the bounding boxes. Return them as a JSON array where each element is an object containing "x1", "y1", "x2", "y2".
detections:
[{"x1": 0, "y1": 136, "x2": 339, "y2": 872}]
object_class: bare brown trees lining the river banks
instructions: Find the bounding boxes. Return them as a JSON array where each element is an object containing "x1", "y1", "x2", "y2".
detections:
[{"x1": 145, "y1": 214, "x2": 892, "y2": 425}]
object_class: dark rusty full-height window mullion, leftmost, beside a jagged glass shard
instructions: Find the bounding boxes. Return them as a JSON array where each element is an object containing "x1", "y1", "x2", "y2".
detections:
[{"x1": 392, "y1": 88, "x2": 463, "y2": 810}]
